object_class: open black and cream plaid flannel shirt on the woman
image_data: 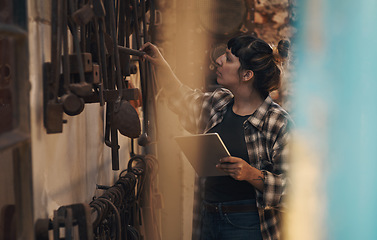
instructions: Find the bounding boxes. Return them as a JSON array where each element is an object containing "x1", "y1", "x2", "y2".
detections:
[{"x1": 168, "y1": 85, "x2": 290, "y2": 239}]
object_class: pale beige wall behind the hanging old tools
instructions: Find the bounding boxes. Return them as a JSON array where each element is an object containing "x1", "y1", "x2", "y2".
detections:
[{"x1": 28, "y1": 0, "x2": 129, "y2": 219}]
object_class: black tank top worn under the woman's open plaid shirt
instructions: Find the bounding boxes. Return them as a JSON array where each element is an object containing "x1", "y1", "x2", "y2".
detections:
[{"x1": 204, "y1": 104, "x2": 255, "y2": 202}]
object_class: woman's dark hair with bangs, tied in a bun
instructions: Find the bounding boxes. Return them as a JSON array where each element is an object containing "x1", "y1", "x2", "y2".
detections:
[{"x1": 228, "y1": 35, "x2": 290, "y2": 97}]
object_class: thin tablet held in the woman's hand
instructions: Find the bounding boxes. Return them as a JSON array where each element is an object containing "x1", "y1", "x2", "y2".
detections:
[{"x1": 174, "y1": 133, "x2": 230, "y2": 177}]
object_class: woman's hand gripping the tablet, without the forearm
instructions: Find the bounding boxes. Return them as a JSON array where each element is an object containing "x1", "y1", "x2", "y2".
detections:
[{"x1": 216, "y1": 157, "x2": 253, "y2": 181}]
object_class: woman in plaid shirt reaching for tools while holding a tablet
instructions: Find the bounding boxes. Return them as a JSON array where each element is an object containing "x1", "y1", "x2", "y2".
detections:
[{"x1": 142, "y1": 35, "x2": 290, "y2": 240}]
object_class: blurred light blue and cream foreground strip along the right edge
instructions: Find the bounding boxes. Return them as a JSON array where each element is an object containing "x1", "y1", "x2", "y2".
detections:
[{"x1": 287, "y1": 0, "x2": 377, "y2": 240}]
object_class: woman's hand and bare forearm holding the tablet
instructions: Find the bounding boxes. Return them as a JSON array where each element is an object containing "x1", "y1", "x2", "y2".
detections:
[{"x1": 216, "y1": 157, "x2": 264, "y2": 191}]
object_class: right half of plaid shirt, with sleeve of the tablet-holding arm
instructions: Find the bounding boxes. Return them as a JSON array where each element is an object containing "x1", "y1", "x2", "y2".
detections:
[{"x1": 248, "y1": 100, "x2": 292, "y2": 239}]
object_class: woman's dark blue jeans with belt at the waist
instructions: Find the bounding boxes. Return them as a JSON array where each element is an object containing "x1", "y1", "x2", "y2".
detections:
[{"x1": 200, "y1": 200, "x2": 262, "y2": 240}]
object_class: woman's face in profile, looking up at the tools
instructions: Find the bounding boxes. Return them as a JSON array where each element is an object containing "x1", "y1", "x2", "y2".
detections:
[{"x1": 216, "y1": 49, "x2": 241, "y2": 89}]
